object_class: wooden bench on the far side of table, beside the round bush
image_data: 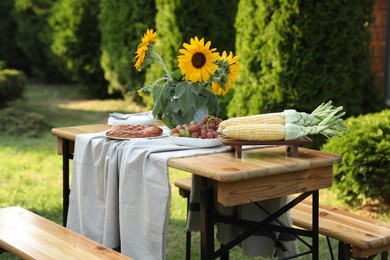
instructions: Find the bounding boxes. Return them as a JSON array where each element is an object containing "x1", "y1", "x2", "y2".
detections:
[{"x1": 174, "y1": 178, "x2": 390, "y2": 260}]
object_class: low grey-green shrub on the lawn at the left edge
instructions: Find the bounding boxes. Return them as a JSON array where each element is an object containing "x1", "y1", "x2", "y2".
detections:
[{"x1": 0, "y1": 107, "x2": 50, "y2": 137}]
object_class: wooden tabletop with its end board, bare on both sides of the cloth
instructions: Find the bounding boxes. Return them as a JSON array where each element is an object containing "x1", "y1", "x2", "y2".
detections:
[{"x1": 52, "y1": 124, "x2": 341, "y2": 206}]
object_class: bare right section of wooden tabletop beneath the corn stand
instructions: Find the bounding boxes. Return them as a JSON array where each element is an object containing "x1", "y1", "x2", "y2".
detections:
[{"x1": 168, "y1": 146, "x2": 341, "y2": 182}]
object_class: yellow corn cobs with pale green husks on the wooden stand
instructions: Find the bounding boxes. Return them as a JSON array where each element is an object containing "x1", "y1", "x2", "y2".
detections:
[{"x1": 218, "y1": 101, "x2": 346, "y2": 141}]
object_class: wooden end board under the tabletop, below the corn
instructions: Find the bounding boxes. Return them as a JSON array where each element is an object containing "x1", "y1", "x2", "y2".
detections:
[{"x1": 217, "y1": 166, "x2": 332, "y2": 206}]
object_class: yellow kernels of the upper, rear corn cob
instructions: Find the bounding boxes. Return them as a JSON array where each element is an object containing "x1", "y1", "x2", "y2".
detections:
[{"x1": 218, "y1": 112, "x2": 285, "y2": 131}]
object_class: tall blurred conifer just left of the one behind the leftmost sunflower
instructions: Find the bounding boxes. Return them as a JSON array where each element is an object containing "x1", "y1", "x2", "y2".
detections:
[{"x1": 48, "y1": 0, "x2": 107, "y2": 97}]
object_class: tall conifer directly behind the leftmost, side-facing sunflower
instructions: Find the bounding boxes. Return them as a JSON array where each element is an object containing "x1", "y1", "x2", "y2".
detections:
[{"x1": 99, "y1": 0, "x2": 156, "y2": 100}]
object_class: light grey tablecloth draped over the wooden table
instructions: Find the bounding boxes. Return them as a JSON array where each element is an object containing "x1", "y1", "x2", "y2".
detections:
[{"x1": 67, "y1": 133, "x2": 298, "y2": 259}]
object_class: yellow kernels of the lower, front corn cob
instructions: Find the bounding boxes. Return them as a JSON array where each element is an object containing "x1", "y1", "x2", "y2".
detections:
[{"x1": 222, "y1": 124, "x2": 286, "y2": 141}]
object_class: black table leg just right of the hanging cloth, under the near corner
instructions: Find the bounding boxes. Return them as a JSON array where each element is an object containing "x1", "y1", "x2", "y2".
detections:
[{"x1": 200, "y1": 177, "x2": 214, "y2": 260}]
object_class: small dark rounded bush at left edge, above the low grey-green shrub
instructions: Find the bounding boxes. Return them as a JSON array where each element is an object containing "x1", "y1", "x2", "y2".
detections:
[{"x1": 0, "y1": 69, "x2": 26, "y2": 107}]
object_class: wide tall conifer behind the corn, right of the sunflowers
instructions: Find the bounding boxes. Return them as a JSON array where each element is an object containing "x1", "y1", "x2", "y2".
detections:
[{"x1": 228, "y1": 0, "x2": 383, "y2": 117}]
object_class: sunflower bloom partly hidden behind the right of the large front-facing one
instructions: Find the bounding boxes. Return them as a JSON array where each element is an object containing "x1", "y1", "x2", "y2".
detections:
[{"x1": 211, "y1": 51, "x2": 240, "y2": 95}]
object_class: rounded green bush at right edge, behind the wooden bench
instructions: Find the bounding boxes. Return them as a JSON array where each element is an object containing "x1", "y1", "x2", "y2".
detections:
[{"x1": 321, "y1": 109, "x2": 390, "y2": 206}]
